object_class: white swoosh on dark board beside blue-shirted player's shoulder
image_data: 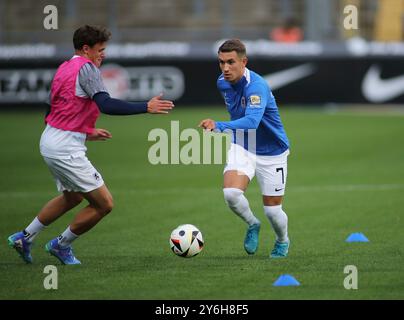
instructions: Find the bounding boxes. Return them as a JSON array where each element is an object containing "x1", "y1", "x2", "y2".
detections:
[{"x1": 264, "y1": 63, "x2": 316, "y2": 90}]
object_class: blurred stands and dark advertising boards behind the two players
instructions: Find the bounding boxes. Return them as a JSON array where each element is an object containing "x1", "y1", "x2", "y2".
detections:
[{"x1": 0, "y1": 0, "x2": 404, "y2": 109}]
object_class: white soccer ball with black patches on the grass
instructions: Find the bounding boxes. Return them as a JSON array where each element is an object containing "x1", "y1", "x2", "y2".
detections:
[{"x1": 169, "y1": 224, "x2": 203, "y2": 258}]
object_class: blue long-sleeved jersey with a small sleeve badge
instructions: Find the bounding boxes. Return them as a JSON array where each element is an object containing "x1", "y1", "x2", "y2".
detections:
[{"x1": 216, "y1": 68, "x2": 289, "y2": 156}]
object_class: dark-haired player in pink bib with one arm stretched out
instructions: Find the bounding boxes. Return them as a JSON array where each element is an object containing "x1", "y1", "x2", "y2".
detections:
[{"x1": 8, "y1": 25, "x2": 174, "y2": 264}]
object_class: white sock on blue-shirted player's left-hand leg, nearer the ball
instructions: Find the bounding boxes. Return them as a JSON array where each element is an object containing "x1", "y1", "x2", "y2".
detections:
[{"x1": 223, "y1": 188, "x2": 260, "y2": 226}]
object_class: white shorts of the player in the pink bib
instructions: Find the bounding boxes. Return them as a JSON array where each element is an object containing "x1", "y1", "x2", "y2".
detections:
[{"x1": 43, "y1": 153, "x2": 104, "y2": 193}]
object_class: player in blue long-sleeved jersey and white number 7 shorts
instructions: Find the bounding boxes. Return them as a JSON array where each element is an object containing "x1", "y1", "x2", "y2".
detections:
[{"x1": 199, "y1": 39, "x2": 290, "y2": 258}]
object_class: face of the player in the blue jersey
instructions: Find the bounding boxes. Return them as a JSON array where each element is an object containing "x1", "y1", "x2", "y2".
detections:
[{"x1": 219, "y1": 51, "x2": 247, "y2": 83}]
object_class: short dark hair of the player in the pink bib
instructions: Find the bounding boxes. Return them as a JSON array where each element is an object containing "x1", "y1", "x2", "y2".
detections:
[{"x1": 73, "y1": 25, "x2": 111, "y2": 50}]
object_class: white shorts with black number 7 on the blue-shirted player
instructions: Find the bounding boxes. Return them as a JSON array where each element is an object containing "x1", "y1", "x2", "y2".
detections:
[{"x1": 223, "y1": 143, "x2": 289, "y2": 196}]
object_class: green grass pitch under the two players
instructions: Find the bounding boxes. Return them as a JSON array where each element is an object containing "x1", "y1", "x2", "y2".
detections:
[{"x1": 0, "y1": 106, "x2": 404, "y2": 300}]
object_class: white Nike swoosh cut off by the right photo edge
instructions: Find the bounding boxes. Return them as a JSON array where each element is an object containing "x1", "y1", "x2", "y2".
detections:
[{"x1": 362, "y1": 65, "x2": 404, "y2": 102}]
